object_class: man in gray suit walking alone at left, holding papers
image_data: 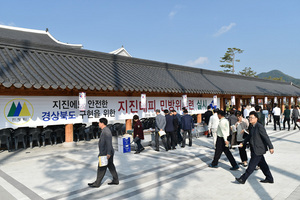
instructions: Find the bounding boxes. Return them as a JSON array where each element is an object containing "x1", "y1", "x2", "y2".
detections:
[{"x1": 88, "y1": 118, "x2": 119, "y2": 187}]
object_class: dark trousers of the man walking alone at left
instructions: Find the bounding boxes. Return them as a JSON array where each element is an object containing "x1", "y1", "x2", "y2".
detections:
[{"x1": 95, "y1": 155, "x2": 119, "y2": 185}]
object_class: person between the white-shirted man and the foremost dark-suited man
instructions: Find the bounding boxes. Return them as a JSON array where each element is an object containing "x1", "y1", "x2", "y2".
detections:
[{"x1": 235, "y1": 112, "x2": 249, "y2": 167}]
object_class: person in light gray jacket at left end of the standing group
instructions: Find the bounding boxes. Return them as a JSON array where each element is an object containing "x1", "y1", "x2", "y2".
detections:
[{"x1": 155, "y1": 109, "x2": 168, "y2": 151}]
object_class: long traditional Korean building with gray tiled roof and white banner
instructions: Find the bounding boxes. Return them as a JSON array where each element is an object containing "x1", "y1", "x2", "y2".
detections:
[{"x1": 0, "y1": 25, "x2": 300, "y2": 144}]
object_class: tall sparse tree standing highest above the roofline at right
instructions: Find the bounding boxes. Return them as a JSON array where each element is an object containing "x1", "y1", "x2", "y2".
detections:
[{"x1": 220, "y1": 48, "x2": 244, "y2": 74}]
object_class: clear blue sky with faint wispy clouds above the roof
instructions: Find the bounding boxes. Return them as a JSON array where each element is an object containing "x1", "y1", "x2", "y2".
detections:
[{"x1": 0, "y1": 0, "x2": 300, "y2": 78}]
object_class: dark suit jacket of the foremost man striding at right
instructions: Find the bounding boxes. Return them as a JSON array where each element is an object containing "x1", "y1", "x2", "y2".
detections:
[{"x1": 243, "y1": 122, "x2": 274, "y2": 156}]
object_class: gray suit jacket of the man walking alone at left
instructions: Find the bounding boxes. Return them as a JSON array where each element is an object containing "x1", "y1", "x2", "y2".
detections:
[{"x1": 98, "y1": 127, "x2": 114, "y2": 156}]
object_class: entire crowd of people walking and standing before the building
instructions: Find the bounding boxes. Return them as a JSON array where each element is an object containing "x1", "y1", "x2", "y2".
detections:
[{"x1": 88, "y1": 104, "x2": 300, "y2": 188}]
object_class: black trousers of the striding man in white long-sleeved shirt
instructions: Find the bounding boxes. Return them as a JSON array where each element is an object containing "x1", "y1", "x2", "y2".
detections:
[{"x1": 212, "y1": 136, "x2": 237, "y2": 167}]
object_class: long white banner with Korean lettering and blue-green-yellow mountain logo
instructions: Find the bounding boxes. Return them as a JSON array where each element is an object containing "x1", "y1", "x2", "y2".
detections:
[{"x1": 0, "y1": 96, "x2": 220, "y2": 129}]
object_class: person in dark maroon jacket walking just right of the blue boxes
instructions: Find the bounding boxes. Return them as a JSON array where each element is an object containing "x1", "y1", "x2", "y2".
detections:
[{"x1": 133, "y1": 115, "x2": 145, "y2": 154}]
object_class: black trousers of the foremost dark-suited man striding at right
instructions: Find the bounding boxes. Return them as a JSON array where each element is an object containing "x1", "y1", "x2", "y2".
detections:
[{"x1": 241, "y1": 150, "x2": 274, "y2": 181}]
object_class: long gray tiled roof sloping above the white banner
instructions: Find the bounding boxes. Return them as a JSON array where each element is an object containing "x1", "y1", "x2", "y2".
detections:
[{"x1": 0, "y1": 28, "x2": 300, "y2": 96}]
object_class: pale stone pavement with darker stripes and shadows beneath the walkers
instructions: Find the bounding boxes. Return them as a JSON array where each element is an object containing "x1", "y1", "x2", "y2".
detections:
[{"x1": 0, "y1": 124, "x2": 300, "y2": 200}]
